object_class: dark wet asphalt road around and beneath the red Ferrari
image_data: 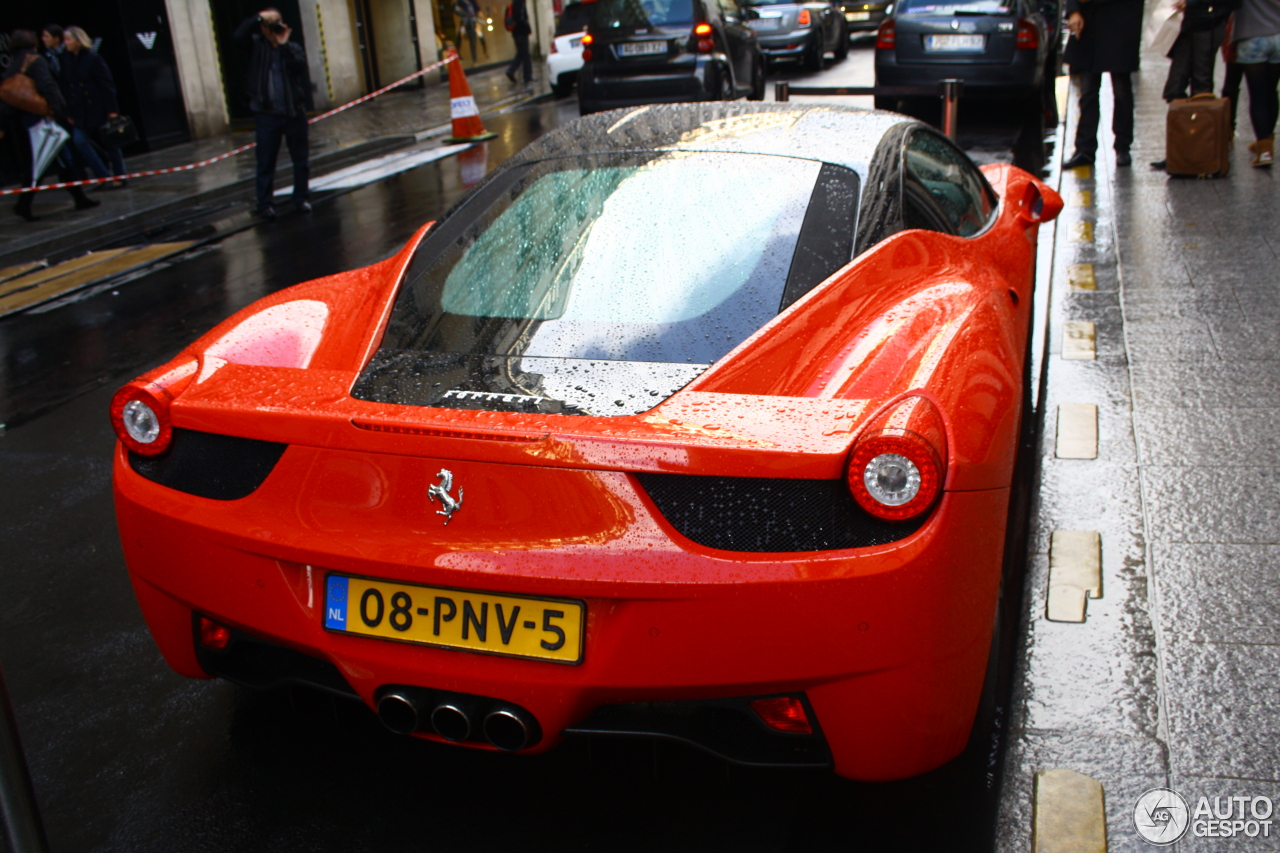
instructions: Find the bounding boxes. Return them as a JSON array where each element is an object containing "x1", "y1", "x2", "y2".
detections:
[{"x1": 0, "y1": 45, "x2": 1054, "y2": 853}]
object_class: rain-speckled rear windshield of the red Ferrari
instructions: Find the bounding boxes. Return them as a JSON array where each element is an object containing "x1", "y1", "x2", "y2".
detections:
[{"x1": 371, "y1": 152, "x2": 834, "y2": 364}]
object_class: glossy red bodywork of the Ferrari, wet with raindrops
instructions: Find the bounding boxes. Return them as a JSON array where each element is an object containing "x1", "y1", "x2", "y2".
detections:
[{"x1": 115, "y1": 157, "x2": 1061, "y2": 780}]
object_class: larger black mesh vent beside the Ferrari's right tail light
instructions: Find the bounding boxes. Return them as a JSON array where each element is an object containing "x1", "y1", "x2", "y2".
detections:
[{"x1": 636, "y1": 474, "x2": 925, "y2": 552}]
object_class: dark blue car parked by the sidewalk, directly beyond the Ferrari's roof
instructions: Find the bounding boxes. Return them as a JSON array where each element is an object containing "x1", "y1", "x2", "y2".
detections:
[{"x1": 876, "y1": 0, "x2": 1056, "y2": 111}]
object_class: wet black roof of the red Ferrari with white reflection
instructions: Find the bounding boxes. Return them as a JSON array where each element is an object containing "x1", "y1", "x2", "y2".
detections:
[{"x1": 508, "y1": 101, "x2": 918, "y2": 177}]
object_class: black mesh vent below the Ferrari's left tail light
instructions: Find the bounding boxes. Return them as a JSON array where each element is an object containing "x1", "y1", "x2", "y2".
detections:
[{"x1": 129, "y1": 429, "x2": 288, "y2": 501}]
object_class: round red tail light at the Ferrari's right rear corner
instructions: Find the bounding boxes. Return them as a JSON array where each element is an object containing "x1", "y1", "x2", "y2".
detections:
[{"x1": 847, "y1": 429, "x2": 943, "y2": 521}]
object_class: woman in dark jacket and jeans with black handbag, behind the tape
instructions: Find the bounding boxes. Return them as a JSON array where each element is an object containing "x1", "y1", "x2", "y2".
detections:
[{"x1": 58, "y1": 27, "x2": 128, "y2": 190}]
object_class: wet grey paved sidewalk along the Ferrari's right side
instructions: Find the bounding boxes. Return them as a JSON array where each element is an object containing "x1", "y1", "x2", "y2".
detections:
[{"x1": 997, "y1": 36, "x2": 1280, "y2": 853}]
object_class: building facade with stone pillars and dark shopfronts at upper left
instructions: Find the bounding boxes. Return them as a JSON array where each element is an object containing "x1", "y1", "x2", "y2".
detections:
[{"x1": 0, "y1": 0, "x2": 556, "y2": 151}]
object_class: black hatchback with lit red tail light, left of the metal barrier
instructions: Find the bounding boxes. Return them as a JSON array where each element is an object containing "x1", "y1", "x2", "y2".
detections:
[{"x1": 577, "y1": 0, "x2": 764, "y2": 115}]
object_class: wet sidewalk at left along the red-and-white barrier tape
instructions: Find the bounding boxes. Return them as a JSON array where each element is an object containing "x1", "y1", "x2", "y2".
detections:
[{"x1": 0, "y1": 68, "x2": 550, "y2": 268}]
